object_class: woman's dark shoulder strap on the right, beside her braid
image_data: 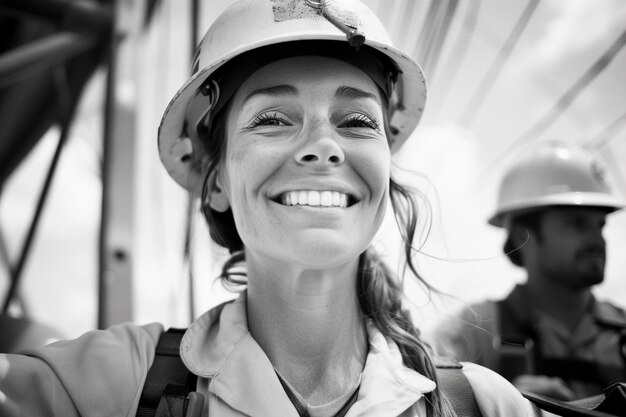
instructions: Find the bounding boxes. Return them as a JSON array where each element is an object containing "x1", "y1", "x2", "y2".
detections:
[{"x1": 434, "y1": 356, "x2": 482, "y2": 417}]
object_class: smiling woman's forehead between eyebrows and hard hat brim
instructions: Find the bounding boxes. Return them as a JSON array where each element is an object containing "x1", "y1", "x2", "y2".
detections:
[{"x1": 235, "y1": 56, "x2": 380, "y2": 101}]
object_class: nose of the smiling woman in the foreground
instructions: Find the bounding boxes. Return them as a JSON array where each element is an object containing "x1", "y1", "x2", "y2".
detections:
[{"x1": 296, "y1": 122, "x2": 346, "y2": 166}]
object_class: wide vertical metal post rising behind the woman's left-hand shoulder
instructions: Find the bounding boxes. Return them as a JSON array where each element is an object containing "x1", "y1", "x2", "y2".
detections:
[{"x1": 98, "y1": 0, "x2": 147, "y2": 328}]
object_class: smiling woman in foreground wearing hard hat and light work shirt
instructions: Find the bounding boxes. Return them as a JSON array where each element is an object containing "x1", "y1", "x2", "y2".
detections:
[{"x1": 0, "y1": 0, "x2": 533, "y2": 417}]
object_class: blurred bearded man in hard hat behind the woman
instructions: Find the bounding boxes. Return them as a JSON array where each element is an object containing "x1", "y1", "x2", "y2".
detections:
[{"x1": 432, "y1": 141, "x2": 626, "y2": 400}]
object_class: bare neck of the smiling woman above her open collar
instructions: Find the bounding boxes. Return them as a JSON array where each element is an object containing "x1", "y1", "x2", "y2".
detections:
[{"x1": 246, "y1": 254, "x2": 368, "y2": 405}]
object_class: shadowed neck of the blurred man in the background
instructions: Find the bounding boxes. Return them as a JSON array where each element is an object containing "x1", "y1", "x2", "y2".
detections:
[{"x1": 526, "y1": 274, "x2": 592, "y2": 331}]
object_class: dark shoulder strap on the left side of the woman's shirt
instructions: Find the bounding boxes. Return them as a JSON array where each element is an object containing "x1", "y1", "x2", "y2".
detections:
[{"x1": 137, "y1": 328, "x2": 201, "y2": 417}]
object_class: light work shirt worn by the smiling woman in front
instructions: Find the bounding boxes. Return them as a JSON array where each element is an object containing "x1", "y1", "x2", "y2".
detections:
[{"x1": 0, "y1": 293, "x2": 534, "y2": 417}]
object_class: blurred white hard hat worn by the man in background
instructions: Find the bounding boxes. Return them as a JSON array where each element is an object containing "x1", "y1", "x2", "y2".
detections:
[{"x1": 489, "y1": 141, "x2": 626, "y2": 227}]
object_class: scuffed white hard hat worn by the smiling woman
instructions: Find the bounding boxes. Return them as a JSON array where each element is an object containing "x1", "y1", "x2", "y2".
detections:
[{"x1": 158, "y1": 0, "x2": 426, "y2": 193}]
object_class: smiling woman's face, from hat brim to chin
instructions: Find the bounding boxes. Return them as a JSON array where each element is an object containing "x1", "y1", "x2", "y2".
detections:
[{"x1": 210, "y1": 56, "x2": 390, "y2": 270}]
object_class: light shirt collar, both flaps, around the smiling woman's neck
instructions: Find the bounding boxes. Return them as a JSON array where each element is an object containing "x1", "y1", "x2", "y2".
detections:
[{"x1": 180, "y1": 292, "x2": 435, "y2": 417}]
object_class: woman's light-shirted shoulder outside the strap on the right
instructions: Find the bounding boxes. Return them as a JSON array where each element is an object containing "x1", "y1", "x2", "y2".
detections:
[{"x1": 462, "y1": 362, "x2": 535, "y2": 417}]
